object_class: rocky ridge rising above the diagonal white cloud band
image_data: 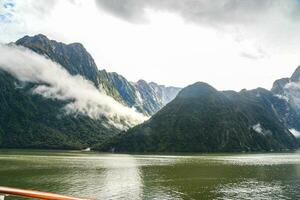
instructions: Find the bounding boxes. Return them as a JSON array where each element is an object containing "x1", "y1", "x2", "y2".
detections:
[{"x1": 16, "y1": 34, "x2": 180, "y2": 116}]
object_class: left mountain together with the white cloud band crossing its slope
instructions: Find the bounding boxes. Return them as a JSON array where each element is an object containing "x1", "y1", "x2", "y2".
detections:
[{"x1": 0, "y1": 34, "x2": 179, "y2": 148}]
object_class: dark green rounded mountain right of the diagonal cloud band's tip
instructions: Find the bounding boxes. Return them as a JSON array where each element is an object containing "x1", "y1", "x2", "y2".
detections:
[{"x1": 103, "y1": 82, "x2": 297, "y2": 152}]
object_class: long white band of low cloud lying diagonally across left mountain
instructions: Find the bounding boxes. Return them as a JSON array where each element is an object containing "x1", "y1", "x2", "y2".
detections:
[{"x1": 0, "y1": 44, "x2": 147, "y2": 129}]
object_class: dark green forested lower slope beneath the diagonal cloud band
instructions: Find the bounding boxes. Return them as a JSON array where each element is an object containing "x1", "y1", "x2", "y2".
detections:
[{"x1": 0, "y1": 70, "x2": 120, "y2": 149}]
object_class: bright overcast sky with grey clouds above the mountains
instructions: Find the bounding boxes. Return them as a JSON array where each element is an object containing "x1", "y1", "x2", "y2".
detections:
[{"x1": 0, "y1": 0, "x2": 300, "y2": 90}]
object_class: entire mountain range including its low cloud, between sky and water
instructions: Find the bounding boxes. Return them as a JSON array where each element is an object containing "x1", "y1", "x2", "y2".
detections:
[{"x1": 0, "y1": 34, "x2": 300, "y2": 152}]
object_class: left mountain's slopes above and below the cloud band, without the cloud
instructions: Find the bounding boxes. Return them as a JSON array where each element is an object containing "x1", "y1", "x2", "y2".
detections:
[{"x1": 0, "y1": 34, "x2": 180, "y2": 149}]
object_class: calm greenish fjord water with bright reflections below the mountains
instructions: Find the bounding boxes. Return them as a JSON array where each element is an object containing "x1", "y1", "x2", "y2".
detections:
[{"x1": 0, "y1": 150, "x2": 300, "y2": 200}]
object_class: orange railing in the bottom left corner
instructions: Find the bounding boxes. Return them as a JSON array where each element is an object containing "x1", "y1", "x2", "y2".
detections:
[{"x1": 0, "y1": 186, "x2": 89, "y2": 200}]
